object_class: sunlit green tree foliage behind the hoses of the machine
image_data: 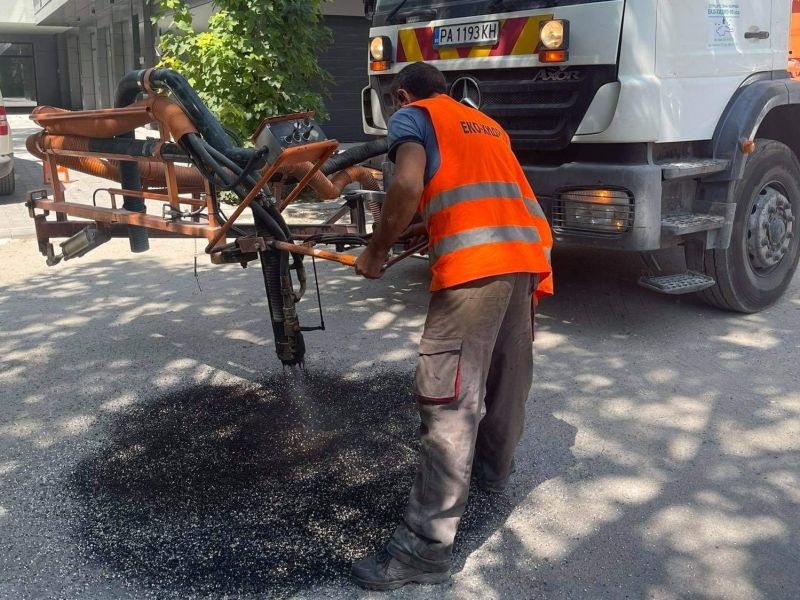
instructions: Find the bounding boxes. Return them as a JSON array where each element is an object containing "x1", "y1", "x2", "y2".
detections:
[{"x1": 154, "y1": 0, "x2": 331, "y2": 138}]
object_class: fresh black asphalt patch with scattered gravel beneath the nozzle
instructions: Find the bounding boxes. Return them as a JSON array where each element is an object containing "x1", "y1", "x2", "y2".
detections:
[{"x1": 72, "y1": 372, "x2": 512, "y2": 598}]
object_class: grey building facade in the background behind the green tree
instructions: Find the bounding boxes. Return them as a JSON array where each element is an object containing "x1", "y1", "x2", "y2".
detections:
[{"x1": 0, "y1": 0, "x2": 369, "y2": 141}]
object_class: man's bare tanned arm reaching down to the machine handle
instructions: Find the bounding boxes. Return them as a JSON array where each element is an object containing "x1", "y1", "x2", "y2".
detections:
[{"x1": 355, "y1": 142, "x2": 426, "y2": 279}]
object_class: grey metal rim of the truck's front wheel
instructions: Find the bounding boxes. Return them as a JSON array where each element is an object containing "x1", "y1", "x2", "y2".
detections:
[{"x1": 747, "y1": 182, "x2": 795, "y2": 275}]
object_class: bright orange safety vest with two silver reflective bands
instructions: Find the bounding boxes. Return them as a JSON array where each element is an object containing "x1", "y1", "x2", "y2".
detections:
[{"x1": 411, "y1": 94, "x2": 553, "y2": 297}]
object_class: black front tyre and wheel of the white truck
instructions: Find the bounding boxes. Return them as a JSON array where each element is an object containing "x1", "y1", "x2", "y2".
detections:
[{"x1": 686, "y1": 139, "x2": 800, "y2": 313}]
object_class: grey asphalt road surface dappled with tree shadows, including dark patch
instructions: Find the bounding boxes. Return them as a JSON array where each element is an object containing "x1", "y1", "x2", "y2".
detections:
[{"x1": 0, "y1": 231, "x2": 800, "y2": 599}]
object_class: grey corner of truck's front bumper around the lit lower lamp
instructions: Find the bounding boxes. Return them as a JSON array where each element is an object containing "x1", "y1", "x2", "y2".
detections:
[{"x1": 523, "y1": 162, "x2": 663, "y2": 251}]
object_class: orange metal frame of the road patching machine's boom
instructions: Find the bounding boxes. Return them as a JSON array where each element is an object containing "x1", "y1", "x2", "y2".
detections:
[{"x1": 27, "y1": 96, "x2": 426, "y2": 268}]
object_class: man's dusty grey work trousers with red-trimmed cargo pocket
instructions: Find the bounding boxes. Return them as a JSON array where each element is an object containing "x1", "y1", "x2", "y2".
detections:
[{"x1": 386, "y1": 273, "x2": 535, "y2": 571}]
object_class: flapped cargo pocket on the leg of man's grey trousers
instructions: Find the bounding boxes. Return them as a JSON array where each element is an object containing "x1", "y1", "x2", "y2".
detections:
[{"x1": 414, "y1": 337, "x2": 461, "y2": 404}]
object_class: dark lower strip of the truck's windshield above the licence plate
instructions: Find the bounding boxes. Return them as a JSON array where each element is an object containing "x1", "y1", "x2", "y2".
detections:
[{"x1": 373, "y1": 0, "x2": 607, "y2": 26}]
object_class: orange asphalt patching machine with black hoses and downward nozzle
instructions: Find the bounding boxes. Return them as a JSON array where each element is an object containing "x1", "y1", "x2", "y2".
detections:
[{"x1": 27, "y1": 69, "x2": 424, "y2": 365}]
